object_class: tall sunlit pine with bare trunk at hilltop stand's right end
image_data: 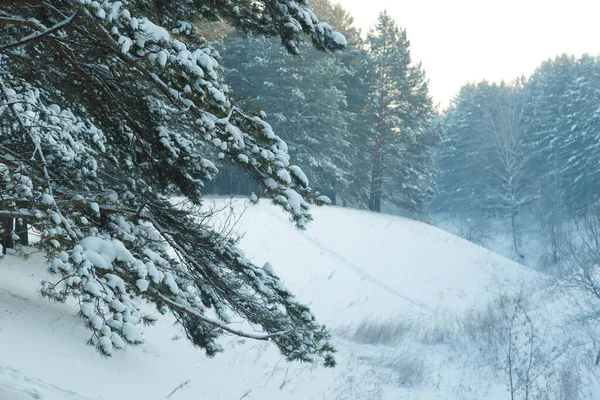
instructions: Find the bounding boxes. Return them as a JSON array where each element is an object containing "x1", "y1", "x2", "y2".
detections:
[{"x1": 367, "y1": 11, "x2": 436, "y2": 212}]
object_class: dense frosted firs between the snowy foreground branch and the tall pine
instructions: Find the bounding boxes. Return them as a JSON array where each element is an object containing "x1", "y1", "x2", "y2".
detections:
[{"x1": 216, "y1": 0, "x2": 368, "y2": 207}]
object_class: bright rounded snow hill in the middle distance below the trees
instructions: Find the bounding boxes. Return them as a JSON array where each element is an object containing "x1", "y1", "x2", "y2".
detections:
[{"x1": 226, "y1": 202, "x2": 538, "y2": 321}]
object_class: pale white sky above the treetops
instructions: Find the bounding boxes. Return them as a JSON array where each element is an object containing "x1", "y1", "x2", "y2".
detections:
[{"x1": 337, "y1": 0, "x2": 600, "y2": 106}]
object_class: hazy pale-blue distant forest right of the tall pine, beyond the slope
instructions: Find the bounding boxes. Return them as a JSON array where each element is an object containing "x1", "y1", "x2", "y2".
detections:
[{"x1": 432, "y1": 55, "x2": 600, "y2": 262}]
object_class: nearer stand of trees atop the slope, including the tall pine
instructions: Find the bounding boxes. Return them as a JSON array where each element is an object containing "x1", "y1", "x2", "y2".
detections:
[{"x1": 207, "y1": 0, "x2": 439, "y2": 213}]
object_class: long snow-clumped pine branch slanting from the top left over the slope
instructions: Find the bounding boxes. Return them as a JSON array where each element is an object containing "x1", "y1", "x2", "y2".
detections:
[{"x1": 59, "y1": 0, "x2": 322, "y2": 228}]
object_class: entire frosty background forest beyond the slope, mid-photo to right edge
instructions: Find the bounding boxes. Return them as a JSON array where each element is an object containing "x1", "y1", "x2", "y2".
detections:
[{"x1": 197, "y1": 0, "x2": 600, "y2": 268}]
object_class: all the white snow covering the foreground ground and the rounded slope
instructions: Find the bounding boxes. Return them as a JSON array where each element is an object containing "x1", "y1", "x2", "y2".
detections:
[{"x1": 0, "y1": 199, "x2": 593, "y2": 400}]
